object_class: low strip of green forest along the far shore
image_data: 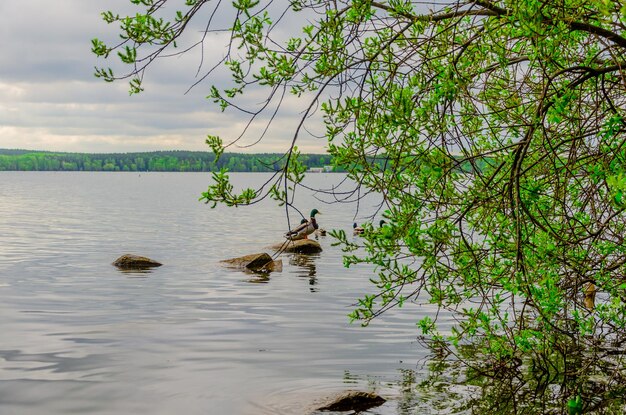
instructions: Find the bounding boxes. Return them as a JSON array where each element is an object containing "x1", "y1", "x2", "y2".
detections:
[{"x1": 0, "y1": 149, "x2": 332, "y2": 172}]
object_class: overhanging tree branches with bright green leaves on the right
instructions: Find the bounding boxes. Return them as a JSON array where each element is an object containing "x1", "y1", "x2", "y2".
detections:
[{"x1": 94, "y1": 0, "x2": 626, "y2": 413}]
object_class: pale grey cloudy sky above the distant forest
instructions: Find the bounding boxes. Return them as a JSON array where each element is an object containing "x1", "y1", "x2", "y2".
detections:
[{"x1": 0, "y1": 0, "x2": 325, "y2": 153}]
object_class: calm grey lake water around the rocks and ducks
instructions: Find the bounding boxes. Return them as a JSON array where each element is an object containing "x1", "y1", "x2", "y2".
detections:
[{"x1": 0, "y1": 172, "x2": 432, "y2": 415}]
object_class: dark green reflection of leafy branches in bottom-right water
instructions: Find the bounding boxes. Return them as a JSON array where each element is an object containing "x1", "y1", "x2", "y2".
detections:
[{"x1": 410, "y1": 335, "x2": 626, "y2": 415}]
